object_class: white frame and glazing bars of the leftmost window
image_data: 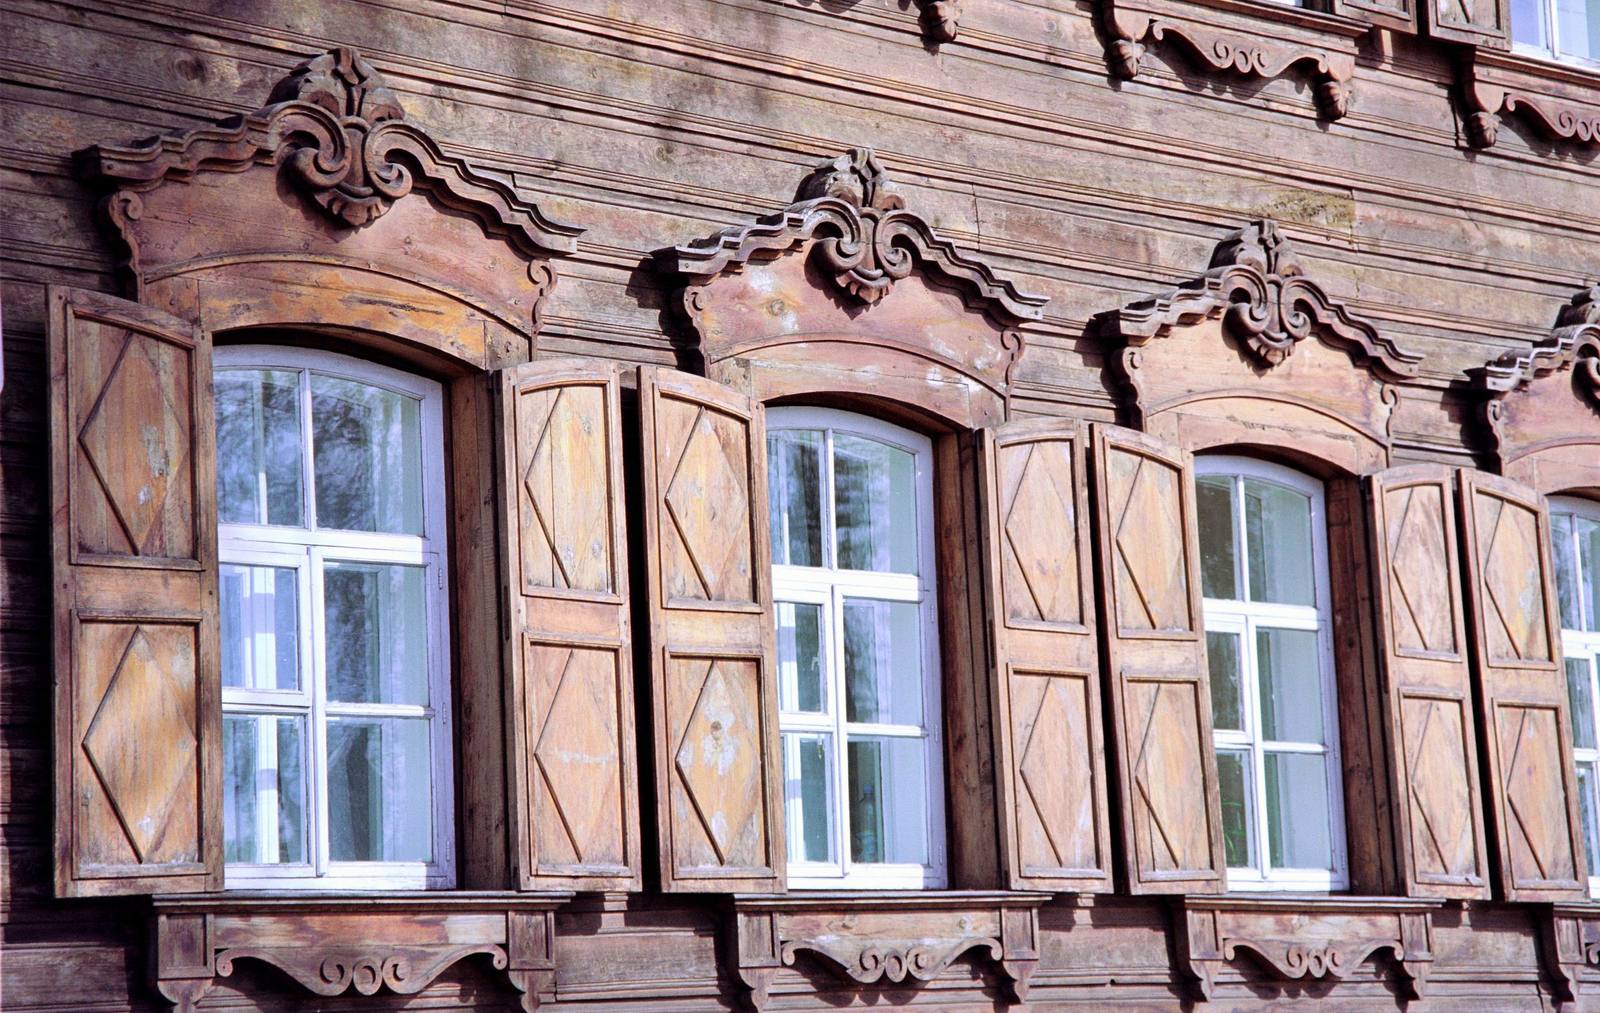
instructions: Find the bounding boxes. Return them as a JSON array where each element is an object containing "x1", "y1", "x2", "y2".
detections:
[{"x1": 213, "y1": 346, "x2": 456, "y2": 890}]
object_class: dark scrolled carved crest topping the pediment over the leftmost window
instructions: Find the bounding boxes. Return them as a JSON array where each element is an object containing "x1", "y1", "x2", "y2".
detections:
[{"x1": 80, "y1": 46, "x2": 582, "y2": 253}]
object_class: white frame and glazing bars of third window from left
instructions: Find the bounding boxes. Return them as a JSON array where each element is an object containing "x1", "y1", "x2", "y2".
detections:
[{"x1": 1195, "y1": 454, "x2": 1350, "y2": 891}]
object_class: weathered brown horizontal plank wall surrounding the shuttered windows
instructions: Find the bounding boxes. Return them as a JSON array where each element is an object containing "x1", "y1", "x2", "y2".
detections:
[{"x1": 0, "y1": 0, "x2": 1600, "y2": 1010}]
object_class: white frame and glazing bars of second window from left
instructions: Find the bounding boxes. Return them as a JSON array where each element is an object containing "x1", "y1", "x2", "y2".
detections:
[{"x1": 766, "y1": 406, "x2": 947, "y2": 890}]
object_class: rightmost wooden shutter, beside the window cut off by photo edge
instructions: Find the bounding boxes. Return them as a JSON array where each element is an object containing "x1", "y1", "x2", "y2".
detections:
[{"x1": 1459, "y1": 469, "x2": 1589, "y2": 901}]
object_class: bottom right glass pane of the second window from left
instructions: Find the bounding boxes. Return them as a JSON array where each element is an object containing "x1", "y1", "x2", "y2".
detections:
[{"x1": 848, "y1": 736, "x2": 928, "y2": 864}]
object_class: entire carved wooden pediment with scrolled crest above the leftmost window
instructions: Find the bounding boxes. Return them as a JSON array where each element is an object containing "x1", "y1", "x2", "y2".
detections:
[{"x1": 78, "y1": 46, "x2": 582, "y2": 362}]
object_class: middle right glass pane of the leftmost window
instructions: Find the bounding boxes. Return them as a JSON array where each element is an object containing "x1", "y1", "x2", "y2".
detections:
[{"x1": 322, "y1": 560, "x2": 427, "y2": 704}]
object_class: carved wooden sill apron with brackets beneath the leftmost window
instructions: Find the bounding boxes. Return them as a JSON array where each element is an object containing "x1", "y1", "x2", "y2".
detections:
[{"x1": 152, "y1": 893, "x2": 571, "y2": 1013}]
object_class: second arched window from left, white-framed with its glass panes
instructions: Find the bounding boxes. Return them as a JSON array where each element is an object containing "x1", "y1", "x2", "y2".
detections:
[{"x1": 766, "y1": 408, "x2": 946, "y2": 888}]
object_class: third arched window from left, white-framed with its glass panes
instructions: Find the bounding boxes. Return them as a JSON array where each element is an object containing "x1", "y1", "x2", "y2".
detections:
[{"x1": 1195, "y1": 456, "x2": 1349, "y2": 890}]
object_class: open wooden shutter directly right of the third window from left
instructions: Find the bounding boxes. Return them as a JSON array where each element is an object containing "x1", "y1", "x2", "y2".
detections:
[{"x1": 1365, "y1": 464, "x2": 1490, "y2": 898}]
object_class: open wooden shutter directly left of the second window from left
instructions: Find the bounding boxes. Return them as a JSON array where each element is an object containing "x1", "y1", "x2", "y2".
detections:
[{"x1": 638, "y1": 366, "x2": 784, "y2": 891}]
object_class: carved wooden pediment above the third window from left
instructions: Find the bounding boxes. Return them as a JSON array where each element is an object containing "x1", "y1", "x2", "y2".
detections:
[{"x1": 1099, "y1": 221, "x2": 1421, "y2": 469}]
